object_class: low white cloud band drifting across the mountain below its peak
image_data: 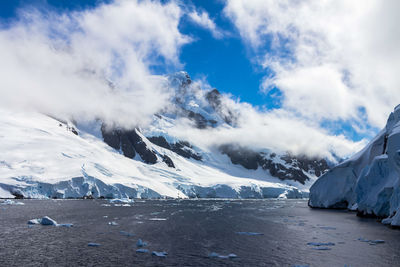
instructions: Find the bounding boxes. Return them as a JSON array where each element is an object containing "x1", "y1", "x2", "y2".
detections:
[{"x1": 169, "y1": 89, "x2": 366, "y2": 161}]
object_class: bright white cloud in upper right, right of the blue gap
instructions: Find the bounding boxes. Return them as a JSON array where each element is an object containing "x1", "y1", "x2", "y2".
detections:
[{"x1": 224, "y1": 0, "x2": 400, "y2": 130}]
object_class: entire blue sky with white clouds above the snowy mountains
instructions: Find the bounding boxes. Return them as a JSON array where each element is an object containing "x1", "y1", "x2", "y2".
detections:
[{"x1": 0, "y1": 0, "x2": 400, "y2": 159}]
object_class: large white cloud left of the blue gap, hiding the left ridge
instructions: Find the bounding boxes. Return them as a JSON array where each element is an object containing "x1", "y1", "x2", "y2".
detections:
[{"x1": 0, "y1": 0, "x2": 190, "y2": 127}]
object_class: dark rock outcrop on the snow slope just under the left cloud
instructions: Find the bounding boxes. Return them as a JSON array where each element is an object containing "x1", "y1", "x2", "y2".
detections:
[{"x1": 101, "y1": 124, "x2": 157, "y2": 164}]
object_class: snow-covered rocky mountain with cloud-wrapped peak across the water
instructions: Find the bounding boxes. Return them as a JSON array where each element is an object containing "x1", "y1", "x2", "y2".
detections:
[{"x1": 0, "y1": 72, "x2": 329, "y2": 198}]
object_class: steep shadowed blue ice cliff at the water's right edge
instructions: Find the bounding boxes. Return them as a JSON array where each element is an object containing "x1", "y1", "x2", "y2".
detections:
[{"x1": 309, "y1": 105, "x2": 400, "y2": 226}]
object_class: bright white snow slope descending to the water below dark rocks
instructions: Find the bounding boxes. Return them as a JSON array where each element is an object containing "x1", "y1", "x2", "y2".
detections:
[{"x1": 0, "y1": 110, "x2": 303, "y2": 199}]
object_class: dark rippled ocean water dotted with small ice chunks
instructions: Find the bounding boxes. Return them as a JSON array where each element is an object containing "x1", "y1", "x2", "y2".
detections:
[{"x1": 0, "y1": 200, "x2": 400, "y2": 266}]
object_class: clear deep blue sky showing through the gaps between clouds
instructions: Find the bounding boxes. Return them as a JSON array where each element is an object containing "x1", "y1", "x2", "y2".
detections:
[{"x1": 0, "y1": 0, "x2": 277, "y2": 108}]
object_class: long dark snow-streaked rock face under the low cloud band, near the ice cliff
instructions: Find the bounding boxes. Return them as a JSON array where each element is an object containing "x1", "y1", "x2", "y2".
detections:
[{"x1": 220, "y1": 145, "x2": 329, "y2": 184}]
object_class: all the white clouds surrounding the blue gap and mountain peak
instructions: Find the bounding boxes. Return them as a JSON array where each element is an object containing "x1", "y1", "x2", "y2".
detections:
[{"x1": 0, "y1": 0, "x2": 376, "y2": 160}]
